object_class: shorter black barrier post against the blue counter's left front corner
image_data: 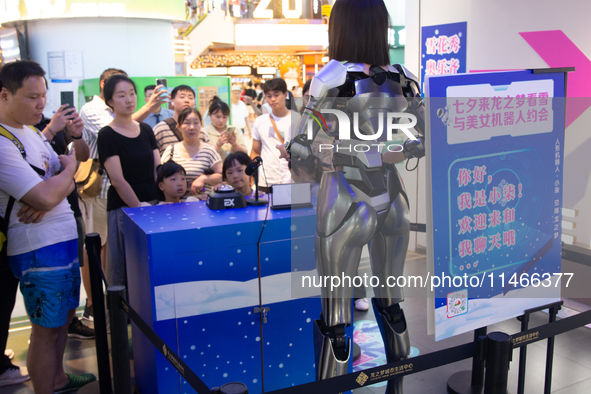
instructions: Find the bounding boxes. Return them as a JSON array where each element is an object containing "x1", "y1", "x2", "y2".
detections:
[{"x1": 107, "y1": 286, "x2": 131, "y2": 394}]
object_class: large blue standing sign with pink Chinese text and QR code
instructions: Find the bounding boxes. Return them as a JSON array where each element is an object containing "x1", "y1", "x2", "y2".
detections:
[{"x1": 425, "y1": 70, "x2": 565, "y2": 340}]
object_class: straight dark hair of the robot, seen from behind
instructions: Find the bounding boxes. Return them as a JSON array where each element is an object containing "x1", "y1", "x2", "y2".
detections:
[{"x1": 328, "y1": 0, "x2": 390, "y2": 66}]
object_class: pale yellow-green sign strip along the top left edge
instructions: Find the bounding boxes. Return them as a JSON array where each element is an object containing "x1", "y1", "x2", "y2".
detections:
[{"x1": 0, "y1": 0, "x2": 185, "y2": 23}]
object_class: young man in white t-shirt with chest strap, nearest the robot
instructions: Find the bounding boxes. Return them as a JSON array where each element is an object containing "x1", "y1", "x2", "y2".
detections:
[{"x1": 250, "y1": 78, "x2": 301, "y2": 191}]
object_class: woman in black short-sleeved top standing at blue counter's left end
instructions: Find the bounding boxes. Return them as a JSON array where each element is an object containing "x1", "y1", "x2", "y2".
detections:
[{"x1": 97, "y1": 75, "x2": 160, "y2": 286}]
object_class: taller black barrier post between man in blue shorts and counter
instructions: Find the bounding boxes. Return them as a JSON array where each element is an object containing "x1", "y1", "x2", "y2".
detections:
[{"x1": 79, "y1": 233, "x2": 113, "y2": 394}]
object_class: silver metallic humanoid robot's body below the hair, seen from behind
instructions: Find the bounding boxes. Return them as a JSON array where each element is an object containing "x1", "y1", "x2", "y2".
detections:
[{"x1": 287, "y1": 60, "x2": 424, "y2": 394}]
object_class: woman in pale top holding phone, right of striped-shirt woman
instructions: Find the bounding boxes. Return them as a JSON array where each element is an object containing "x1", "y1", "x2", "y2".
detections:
[{"x1": 203, "y1": 96, "x2": 248, "y2": 160}]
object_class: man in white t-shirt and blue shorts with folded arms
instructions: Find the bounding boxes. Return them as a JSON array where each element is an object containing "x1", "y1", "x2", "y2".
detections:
[{"x1": 0, "y1": 61, "x2": 96, "y2": 394}]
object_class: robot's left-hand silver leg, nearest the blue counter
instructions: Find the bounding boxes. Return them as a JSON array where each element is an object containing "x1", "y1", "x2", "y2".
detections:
[{"x1": 314, "y1": 171, "x2": 377, "y2": 380}]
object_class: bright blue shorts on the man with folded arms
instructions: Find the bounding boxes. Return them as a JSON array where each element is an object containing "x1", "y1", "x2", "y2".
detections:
[{"x1": 8, "y1": 239, "x2": 80, "y2": 328}]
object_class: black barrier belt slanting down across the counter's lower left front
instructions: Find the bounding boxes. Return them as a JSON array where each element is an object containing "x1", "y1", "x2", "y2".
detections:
[{"x1": 121, "y1": 299, "x2": 211, "y2": 394}]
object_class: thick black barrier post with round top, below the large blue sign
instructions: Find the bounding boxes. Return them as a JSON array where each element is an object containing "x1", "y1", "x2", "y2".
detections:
[{"x1": 484, "y1": 332, "x2": 512, "y2": 394}]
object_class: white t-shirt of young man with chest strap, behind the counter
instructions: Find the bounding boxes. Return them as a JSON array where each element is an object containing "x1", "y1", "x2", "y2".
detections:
[{"x1": 252, "y1": 111, "x2": 301, "y2": 186}]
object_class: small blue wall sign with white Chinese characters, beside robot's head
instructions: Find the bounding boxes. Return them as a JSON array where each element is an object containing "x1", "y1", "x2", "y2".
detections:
[{"x1": 421, "y1": 22, "x2": 468, "y2": 92}]
